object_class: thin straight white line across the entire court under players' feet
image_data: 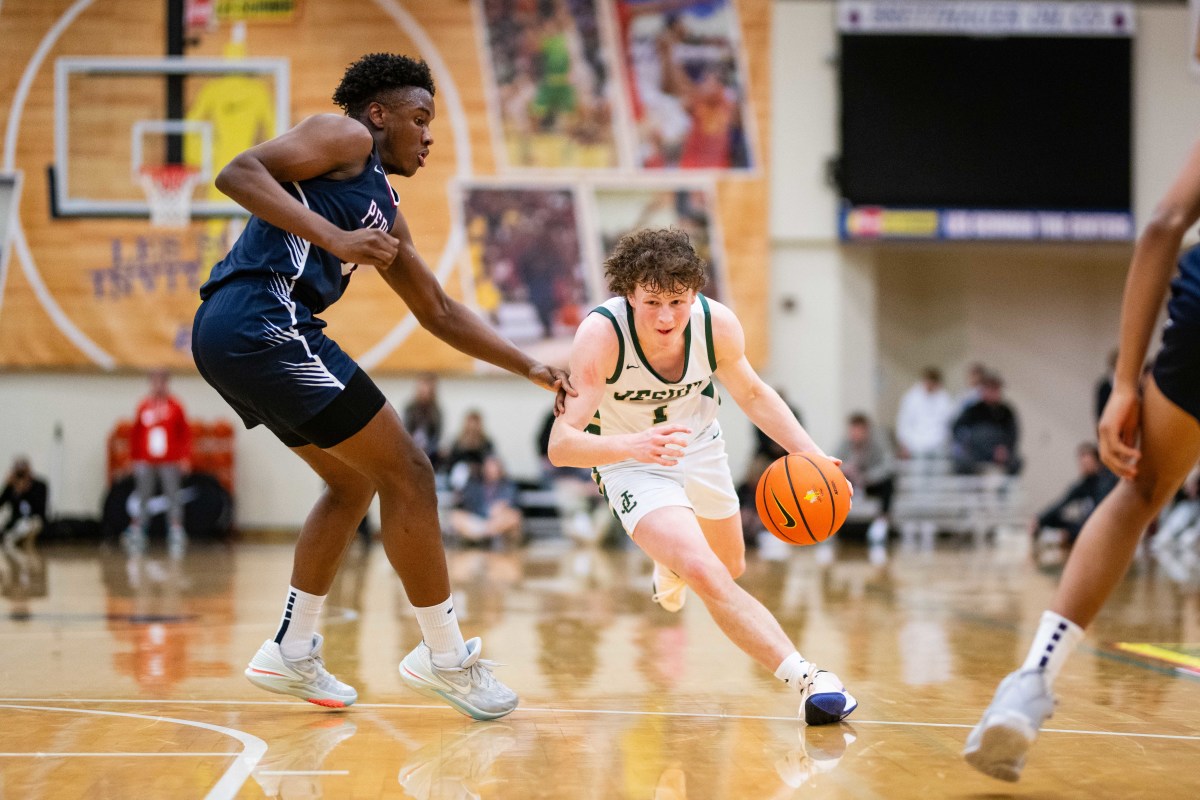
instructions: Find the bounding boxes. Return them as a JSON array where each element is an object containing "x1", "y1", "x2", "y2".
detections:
[{"x1": 0, "y1": 697, "x2": 1200, "y2": 746}]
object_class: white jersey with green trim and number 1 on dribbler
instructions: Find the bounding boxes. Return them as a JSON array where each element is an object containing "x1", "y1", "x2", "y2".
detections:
[{"x1": 586, "y1": 294, "x2": 721, "y2": 440}]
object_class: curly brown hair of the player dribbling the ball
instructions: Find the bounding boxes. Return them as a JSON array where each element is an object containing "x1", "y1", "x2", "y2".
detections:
[{"x1": 604, "y1": 228, "x2": 708, "y2": 297}]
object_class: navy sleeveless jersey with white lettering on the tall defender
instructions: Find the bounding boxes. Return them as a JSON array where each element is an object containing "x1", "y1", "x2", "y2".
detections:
[{"x1": 200, "y1": 150, "x2": 400, "y2": 313}]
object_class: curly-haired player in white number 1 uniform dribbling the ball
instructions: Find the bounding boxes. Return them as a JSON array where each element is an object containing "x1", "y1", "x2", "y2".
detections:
[{"x1": 548, "y1": 229, "x2": 857, "y2": 724}]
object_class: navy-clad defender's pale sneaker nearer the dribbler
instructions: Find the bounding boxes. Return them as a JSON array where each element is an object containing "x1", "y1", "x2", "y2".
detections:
[{"x1": 400, "y1": 637, "x2": 517, "y2": 720}]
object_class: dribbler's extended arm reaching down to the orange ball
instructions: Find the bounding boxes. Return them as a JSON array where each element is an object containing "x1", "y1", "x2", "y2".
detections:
[{"x1": 708, "y1": 300, "x2": 826, "y2": 456}]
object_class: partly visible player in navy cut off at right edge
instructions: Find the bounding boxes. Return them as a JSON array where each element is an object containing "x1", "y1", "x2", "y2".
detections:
[{"x1": 964, "y1": 143, "x2": 1200, "y2": 781}]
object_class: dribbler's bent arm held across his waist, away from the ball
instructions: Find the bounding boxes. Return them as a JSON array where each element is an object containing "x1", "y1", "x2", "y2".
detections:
[{"x1": 546, "y1": 314, "x2": 691, "y2": 467}]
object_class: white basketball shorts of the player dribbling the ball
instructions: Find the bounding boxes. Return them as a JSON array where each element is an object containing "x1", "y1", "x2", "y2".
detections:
[{"x1": 595, "y1": 422, "x2": 738, "y2": 536}]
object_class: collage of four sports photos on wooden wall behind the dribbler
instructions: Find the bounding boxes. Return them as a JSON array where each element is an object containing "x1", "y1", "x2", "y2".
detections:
[{"x1": 457, "y1": 0, "x2": 756, "y2": 359}]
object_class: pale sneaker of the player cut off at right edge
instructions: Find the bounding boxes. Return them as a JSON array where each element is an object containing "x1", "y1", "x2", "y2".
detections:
[{"x1": 962, "y1": 669, "x2": 1055, "y2": 781}]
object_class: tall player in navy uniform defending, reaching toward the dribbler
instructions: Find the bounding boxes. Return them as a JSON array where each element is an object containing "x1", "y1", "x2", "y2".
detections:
[{"x1": 192, "y1": 53, "x2": 570, "y2": 720}]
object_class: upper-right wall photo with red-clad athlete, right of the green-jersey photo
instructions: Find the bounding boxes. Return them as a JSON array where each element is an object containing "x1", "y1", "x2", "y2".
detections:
[{"x1": 614, "y1": 0, "x2": 755, "y2": 169}]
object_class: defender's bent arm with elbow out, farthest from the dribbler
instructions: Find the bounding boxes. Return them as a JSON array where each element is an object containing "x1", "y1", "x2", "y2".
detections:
[{"x1": 216, "y1": 114, "x2": 396, "y2": 266}]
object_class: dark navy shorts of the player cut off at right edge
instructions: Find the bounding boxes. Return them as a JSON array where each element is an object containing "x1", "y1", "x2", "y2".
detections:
[{"x1": 1154, "y1": 248, "x2": 1200, "y2": 421}]
